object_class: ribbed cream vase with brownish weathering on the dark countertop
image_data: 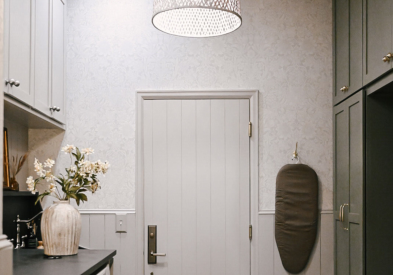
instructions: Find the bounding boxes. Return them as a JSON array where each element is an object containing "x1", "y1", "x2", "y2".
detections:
[{"x1": 41, "y1": 200, "x2": 82, "y2": 256}]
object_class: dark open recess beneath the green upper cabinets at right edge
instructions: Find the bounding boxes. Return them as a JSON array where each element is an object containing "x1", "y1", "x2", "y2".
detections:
[{"x1": 365, "y1": 89, "x2": 393, "y2": 275}]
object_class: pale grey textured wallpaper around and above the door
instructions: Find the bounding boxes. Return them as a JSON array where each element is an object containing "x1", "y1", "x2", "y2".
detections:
[{"x1": 59, "y1": 0, "x2": 332, "y2": 210}]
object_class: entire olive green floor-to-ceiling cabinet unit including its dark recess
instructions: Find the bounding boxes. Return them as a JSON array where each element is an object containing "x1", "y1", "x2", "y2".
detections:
[{"x1": 333, "y1": 0, "x2": 393, "y2": 275}]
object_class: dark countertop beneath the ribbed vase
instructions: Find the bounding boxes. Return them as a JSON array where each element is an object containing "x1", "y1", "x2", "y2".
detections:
[{"x1": 13, "y1": 249, "x2": 116, "y2": 275}]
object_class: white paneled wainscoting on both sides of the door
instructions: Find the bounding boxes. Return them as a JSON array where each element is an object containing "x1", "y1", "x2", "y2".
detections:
[{"x1": 80, "y1": 210, "x2": 334, "y2": 275}]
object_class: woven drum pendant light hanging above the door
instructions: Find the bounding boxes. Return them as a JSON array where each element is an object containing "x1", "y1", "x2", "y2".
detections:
[{"x1": 152, "y1": 0, "x2": 242, "y2": 37}]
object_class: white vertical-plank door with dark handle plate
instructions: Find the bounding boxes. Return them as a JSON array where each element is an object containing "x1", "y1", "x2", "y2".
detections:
[{"x1": 143, "y1": 99, "x2": 250, "y2": 275}]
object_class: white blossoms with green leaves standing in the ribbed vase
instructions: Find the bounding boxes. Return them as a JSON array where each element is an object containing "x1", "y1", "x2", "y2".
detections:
[{"x1": 26, "y1": 145, "x2": 110, "y2": 205}]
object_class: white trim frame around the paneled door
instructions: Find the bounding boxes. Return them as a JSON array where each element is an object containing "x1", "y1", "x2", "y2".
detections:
[{"x1": 135, "y1": 90, "x2": 259, "y2": 275}]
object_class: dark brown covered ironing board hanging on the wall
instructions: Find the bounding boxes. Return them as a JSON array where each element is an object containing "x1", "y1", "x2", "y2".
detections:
[{"x1": 275, "y1": 164, "x2": 318, "y2": 274}]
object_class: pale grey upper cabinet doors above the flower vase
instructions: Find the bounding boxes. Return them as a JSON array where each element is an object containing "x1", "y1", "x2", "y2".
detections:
[{"x1": 4, "y1": 0, "x2": 66, "y2": 123}]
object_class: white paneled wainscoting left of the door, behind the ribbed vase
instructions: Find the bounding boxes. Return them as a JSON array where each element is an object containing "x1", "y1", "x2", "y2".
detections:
[{"x1": 80, "y1": 211, "x2": 136, "y2": 275}]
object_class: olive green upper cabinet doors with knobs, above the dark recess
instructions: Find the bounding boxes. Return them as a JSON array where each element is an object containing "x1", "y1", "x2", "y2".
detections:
[{"x1": 333, "y1": 0, "x2": 393, "y2": 105}]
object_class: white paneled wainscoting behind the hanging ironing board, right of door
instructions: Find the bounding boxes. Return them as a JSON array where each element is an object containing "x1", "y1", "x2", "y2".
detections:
[{"x1": 258, "y1": 211, "x2": 334, "y2": 275}]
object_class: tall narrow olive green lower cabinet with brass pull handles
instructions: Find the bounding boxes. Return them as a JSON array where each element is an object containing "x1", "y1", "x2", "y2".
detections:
[{"x1": 334, "y1": 91, "x2": 364, "y2": 275}]
